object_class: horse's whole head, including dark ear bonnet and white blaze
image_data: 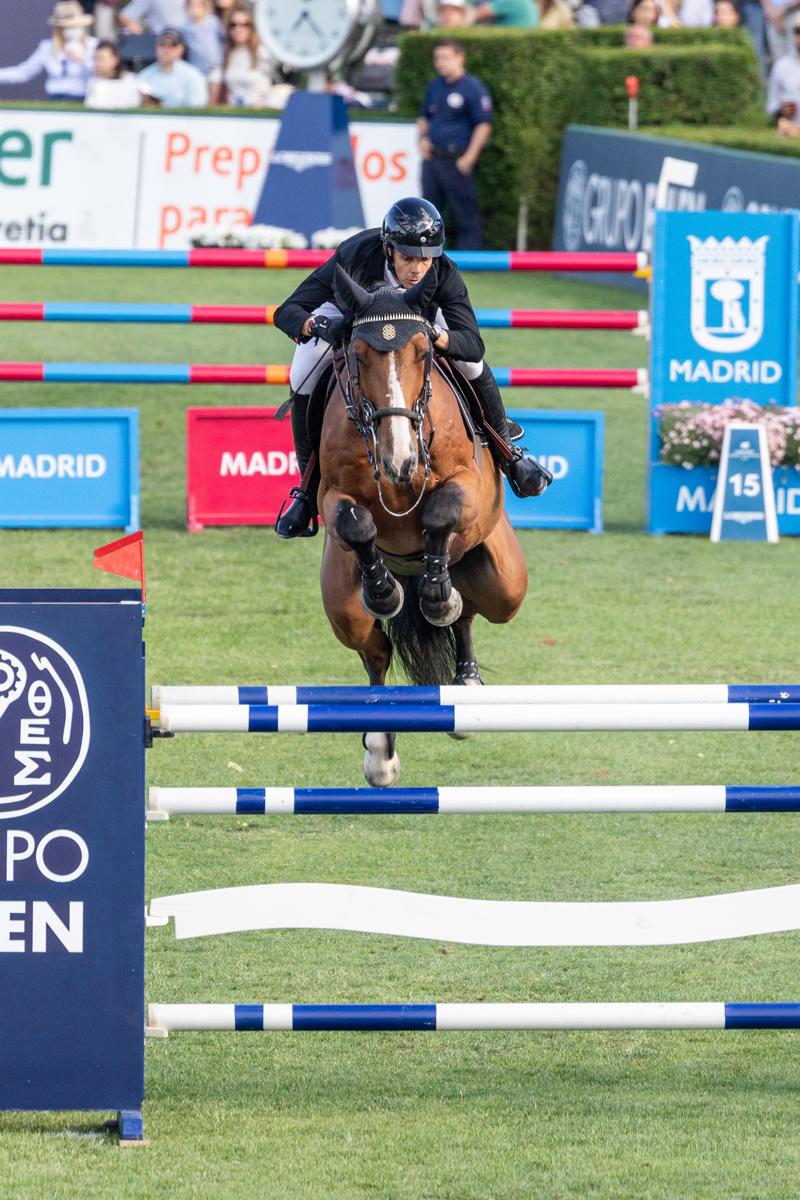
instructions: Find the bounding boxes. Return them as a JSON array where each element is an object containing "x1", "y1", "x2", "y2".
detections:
[{"x1": 336, "y1": 266, "x2": 437, "y2": 484}]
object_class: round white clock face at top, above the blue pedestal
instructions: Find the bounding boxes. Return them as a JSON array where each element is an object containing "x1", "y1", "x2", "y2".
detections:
[{"x1": 255, "y1": 0, "x2": 380, "y2": 71}]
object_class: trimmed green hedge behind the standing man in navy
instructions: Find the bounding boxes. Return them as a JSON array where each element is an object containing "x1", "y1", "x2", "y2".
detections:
[{"x1": 397, "y1": 26, "x2": 762, "y2": 248}]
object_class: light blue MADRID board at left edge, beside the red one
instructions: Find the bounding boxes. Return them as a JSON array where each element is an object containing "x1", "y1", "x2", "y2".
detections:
[{"x1": 0, "y1": 408, "x2": 139, "y2": 533}]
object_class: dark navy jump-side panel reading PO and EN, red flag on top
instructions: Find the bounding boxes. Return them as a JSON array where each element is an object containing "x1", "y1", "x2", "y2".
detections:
[{"x1": 0, "y1": 589, "x2": 145, "y2": 1138}]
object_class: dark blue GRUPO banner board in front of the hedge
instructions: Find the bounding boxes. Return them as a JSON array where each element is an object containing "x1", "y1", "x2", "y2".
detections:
[{"x1": 553, "y1": 125, "x2": 800, "y2": 290}]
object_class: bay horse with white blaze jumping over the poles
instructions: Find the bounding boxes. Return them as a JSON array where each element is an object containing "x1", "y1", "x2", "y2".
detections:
[{"x1": 318, "y1": 266, "x2": 528, "y2": 787}]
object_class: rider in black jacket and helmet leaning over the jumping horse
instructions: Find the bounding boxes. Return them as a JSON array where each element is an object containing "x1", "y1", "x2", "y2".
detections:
[{"x1": 275, "y1": 196, "x2": 552, "y2": 538}]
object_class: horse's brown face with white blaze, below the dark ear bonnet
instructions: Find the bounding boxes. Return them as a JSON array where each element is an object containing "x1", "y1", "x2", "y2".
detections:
[{"x1": 353, "y1": 331, "x2": 429, "y2": 484}]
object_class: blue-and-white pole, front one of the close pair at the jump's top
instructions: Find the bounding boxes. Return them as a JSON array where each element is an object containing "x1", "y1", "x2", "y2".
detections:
[{"x1": 158, "y1": 703, "x2": 800, "y2": 733}]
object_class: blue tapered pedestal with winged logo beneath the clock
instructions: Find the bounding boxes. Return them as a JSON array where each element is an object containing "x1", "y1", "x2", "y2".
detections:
[{"x1": 253, "y1": 91, "x2": 363, "y2": 238}]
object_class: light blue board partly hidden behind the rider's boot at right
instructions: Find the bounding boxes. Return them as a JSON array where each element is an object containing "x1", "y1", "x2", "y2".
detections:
[{"x1": 505, "y1": 408, "x2": 604, "y2": 533}]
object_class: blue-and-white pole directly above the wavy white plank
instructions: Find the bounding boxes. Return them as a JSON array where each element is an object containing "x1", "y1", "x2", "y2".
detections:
[{"x1": 148, "y1": 785, "x2": 800, "y2": 821}]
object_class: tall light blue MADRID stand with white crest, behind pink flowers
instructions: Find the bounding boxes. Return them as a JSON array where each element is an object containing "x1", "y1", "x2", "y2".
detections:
[{"x1": 648, "y1": 212, "x2": 800, "y2": 534}]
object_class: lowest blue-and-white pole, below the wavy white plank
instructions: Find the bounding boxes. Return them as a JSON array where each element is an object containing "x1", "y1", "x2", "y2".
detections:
[{"x1": 146, "y1": 1001, "x2": 800, "y2": 1037}]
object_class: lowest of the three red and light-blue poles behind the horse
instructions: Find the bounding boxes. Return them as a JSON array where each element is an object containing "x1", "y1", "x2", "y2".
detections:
[{"x1": 0, "y1": 362, "x2": 649, "y2": 391}]
